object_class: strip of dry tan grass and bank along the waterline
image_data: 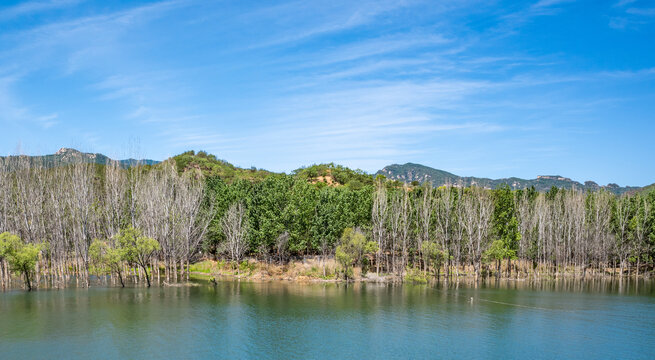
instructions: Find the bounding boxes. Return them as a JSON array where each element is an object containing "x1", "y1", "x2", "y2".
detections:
[{"x1": 0, "y1": 258, "x2": 655, "y2": 291}]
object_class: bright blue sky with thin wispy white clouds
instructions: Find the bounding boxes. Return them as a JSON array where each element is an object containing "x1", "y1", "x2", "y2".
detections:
[{"x1": 0, "y1": 0, "x2": 655, "y2": 186}]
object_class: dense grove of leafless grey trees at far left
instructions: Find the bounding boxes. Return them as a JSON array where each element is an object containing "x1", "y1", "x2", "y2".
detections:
[{"x1": 0, "y1": 157, "x2": 212, "y2": 287}]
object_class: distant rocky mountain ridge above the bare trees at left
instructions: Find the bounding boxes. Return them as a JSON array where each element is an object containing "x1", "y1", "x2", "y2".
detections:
[{"x1": 0, "y1": 148, "x2": 159, "y2": 168}]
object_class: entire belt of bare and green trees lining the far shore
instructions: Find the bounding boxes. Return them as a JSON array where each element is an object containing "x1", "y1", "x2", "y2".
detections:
[{"x1": 0, "y1": 152, "x2": 655, "y2": 288}]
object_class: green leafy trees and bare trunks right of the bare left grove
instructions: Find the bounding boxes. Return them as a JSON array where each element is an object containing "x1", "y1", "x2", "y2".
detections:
[{"x1": 205, "y1": 175, "x2": 655, "y2": 276}]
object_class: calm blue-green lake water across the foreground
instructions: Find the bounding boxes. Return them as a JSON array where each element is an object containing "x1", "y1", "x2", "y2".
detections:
[{"x1": 0, "y1": 280, "x2": 655, "y2": 359}]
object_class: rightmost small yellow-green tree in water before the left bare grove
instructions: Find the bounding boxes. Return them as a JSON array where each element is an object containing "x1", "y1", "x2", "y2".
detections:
[{"x1": 116, "y1": 226, "x2": 161, "y2": 287}]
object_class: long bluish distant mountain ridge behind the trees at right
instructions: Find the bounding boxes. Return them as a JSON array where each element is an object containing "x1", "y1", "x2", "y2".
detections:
[{"x1": 377, "y1": 163, "x2": 640, "y2": 194}]
